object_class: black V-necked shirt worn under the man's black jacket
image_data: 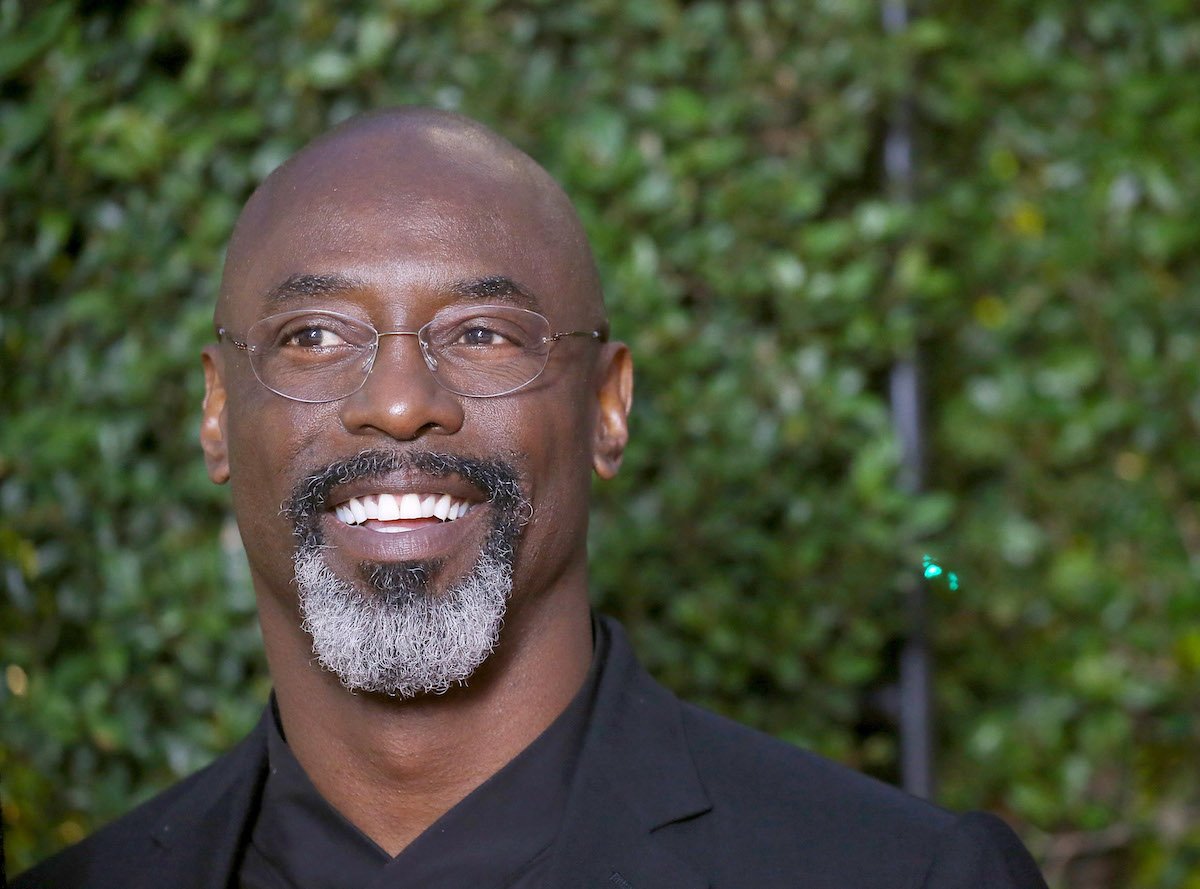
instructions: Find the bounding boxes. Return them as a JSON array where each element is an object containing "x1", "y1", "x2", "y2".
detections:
[{"x1": 238, "y1": 621, "x2": 607, "y2": 889}]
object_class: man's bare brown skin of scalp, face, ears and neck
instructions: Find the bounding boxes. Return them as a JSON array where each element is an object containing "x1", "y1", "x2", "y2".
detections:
[{"x1": 200, "y1": 110, "x2": 632, "y2": 854}]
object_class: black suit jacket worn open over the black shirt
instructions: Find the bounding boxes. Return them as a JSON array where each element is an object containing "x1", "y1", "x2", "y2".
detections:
[{"x1": 13, "y1": 620, "x2": 1045, "y2": 889}]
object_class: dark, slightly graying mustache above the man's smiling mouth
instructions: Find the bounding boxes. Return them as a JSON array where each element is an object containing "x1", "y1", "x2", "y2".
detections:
[{"x1": 282, "y1": 450, "x2": 532, "y2": 547}]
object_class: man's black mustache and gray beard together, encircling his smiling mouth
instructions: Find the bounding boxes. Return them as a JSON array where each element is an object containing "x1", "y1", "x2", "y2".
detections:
[{"x1": 283, "y1": 451, "x2": 529, "y2": 698}]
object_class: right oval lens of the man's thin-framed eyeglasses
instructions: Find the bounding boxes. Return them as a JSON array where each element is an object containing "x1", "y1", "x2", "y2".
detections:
[{"x1": 420, "y1": 306, "x2": 550, "y2": 398}]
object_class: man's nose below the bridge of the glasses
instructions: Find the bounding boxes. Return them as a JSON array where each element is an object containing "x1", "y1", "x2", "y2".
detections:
[{"x1": 341, "y1": 332, "x2": 463, "y2": 442}]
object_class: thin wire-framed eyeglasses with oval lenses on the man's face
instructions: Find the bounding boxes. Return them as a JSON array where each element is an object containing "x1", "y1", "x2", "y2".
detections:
[{"x1": 217, "y1": 306, "x2": 608, "y2": 404}]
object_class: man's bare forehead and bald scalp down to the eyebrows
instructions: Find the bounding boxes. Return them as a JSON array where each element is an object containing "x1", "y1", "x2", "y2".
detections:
[{"x1": 222, "y1": 131, "x2": 595, "y2": 323}]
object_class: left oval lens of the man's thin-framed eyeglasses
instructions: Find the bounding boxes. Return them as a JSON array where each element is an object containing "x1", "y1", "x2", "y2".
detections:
[{"x1": 246, "y1": 312, "x2": 377, "y2": 402}]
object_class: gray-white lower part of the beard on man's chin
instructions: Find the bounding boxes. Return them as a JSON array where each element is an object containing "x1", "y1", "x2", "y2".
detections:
[{"x1": 295, "y1": 547, "x2": 512, "y2": 698}]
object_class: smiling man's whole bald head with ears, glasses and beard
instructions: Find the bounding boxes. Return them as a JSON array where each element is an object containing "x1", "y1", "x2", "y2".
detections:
[{"x1": 202, "y1": 109, "x2": 631, "y2": 696}]
